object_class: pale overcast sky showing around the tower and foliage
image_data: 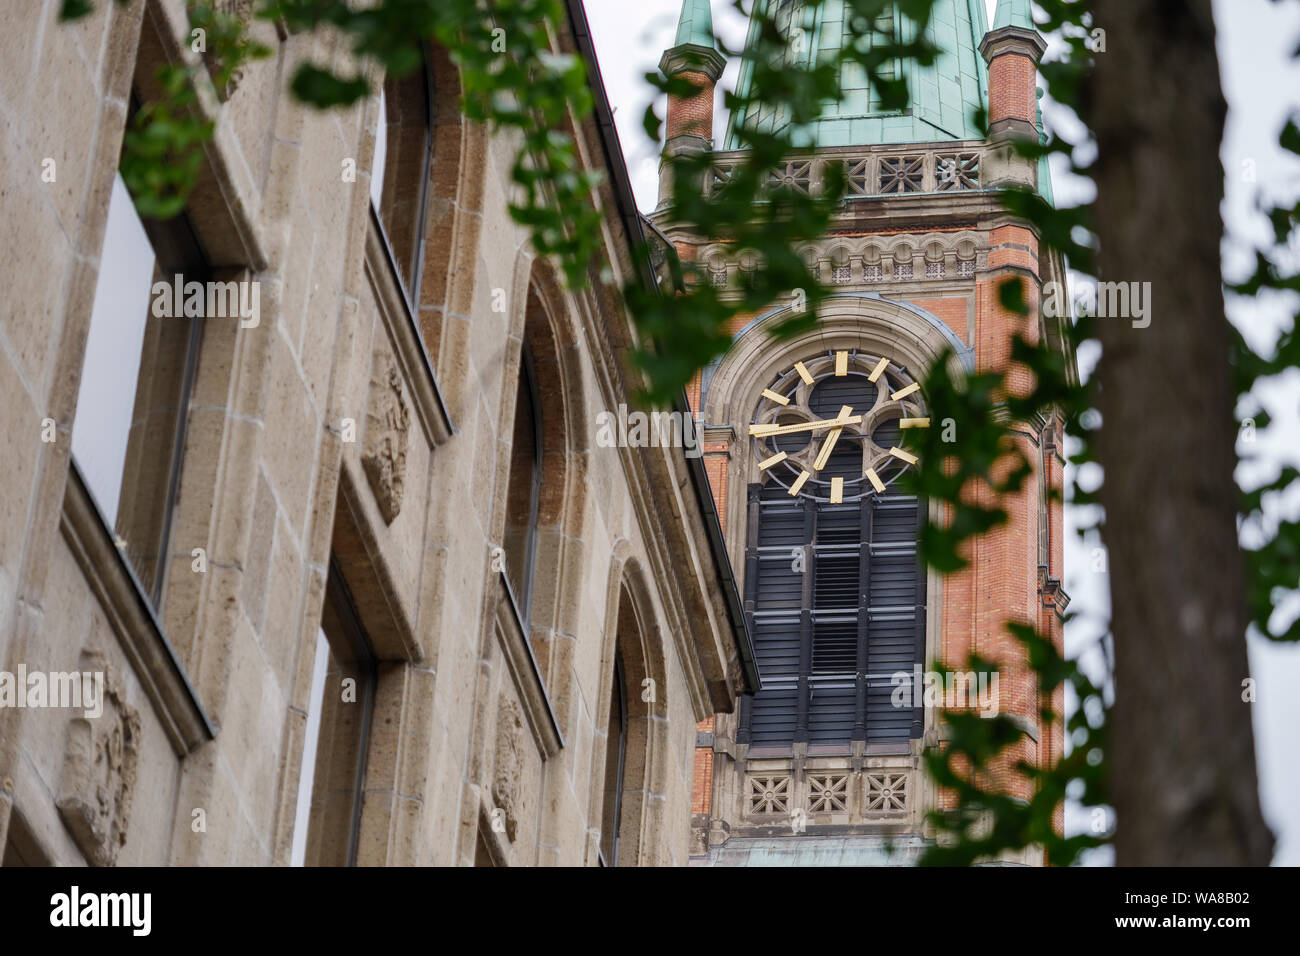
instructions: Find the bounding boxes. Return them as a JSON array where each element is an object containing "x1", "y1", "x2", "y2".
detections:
[{"x1": 586, "y1": 0, "x2": 1300, "y2": 866}]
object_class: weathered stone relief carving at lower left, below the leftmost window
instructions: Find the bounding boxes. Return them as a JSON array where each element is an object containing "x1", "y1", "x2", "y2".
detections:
[{"x1": 56, "y1": 649, "x2": 140, "y2": 866}]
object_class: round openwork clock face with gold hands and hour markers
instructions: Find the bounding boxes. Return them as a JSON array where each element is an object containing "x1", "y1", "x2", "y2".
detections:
[{"x1": 749, "y1": 349, "x2": 930, "y2": 505}]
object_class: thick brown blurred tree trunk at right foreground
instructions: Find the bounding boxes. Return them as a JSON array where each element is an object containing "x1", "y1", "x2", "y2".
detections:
[{"x1": 1086, "y1": 0, "x2": 1273, "y2": 865}]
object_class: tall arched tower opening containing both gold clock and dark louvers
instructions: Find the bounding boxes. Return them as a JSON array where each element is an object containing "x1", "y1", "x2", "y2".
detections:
[{"x1": 738, "y1": 351, "x2": 928, "y2": 752}]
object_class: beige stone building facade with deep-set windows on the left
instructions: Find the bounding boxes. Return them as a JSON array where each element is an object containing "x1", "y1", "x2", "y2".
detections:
[{"x1": 0, "y1": 0, "x2": 754, "y2": 865}]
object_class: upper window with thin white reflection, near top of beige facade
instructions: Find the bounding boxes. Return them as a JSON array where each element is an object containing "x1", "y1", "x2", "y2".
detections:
[{"x1": 371, "y1": 51, "x2": 433, "y2": 306}]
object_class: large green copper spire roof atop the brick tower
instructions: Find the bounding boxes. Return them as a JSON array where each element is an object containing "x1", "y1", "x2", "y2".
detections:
[{"x1": 728, "y1": 0, "x2": 987, "y2": 150}]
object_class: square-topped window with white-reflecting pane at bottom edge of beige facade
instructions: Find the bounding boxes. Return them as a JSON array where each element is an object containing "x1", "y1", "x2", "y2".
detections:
[{"x1": 293, "y1": 561, "x2": 378, "y2": 866}]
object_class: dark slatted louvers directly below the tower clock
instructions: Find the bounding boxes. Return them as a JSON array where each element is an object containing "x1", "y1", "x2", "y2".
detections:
[{"x1": 737, "y1": 484, "x2": 926, "y2": 748}]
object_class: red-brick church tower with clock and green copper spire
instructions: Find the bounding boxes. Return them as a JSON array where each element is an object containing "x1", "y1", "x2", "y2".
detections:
[{"x1": 654, "y1": 0, "x2": 1069, "y2": 865}]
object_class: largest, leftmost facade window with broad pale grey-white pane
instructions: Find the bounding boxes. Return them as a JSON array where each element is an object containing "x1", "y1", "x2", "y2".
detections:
[{"x1": 73, "y1": 176, "x2": 209, "y2": 607}]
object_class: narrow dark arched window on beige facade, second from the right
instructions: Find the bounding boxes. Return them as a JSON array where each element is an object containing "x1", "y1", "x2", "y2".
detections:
[{"x1": 502, "y1": 345, "x2": 542, "y2": 613}]
